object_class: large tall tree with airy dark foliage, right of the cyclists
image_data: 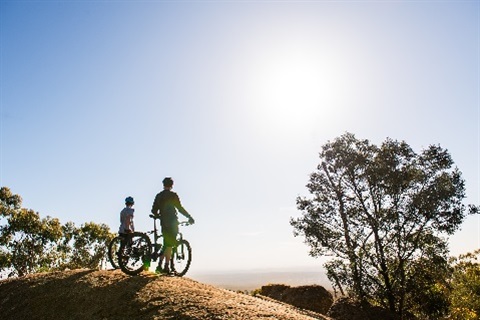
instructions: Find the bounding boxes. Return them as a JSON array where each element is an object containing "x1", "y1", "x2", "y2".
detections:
[{"x1": 290, "y1": 133, "x2": 477, "y2": 315}]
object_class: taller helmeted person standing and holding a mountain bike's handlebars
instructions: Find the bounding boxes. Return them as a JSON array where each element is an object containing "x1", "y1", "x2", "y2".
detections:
[{"x1": 152, "y1": 177, "x2": 195, "y2": 274}]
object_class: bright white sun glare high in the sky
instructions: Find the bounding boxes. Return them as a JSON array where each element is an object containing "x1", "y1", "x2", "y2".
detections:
[{"x1": 248, "y1": 47, "x2": 339, "y2": 132}]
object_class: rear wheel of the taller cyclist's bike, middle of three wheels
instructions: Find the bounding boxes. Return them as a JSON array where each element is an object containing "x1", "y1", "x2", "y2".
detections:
[{"x1": 118, "y1": 232, "x2": 152, "y2": 276}]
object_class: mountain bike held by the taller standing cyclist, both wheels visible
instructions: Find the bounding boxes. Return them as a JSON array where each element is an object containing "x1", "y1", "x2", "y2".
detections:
[{"x1": 118, "y1": 214, "x2": 192, "y2": 277}]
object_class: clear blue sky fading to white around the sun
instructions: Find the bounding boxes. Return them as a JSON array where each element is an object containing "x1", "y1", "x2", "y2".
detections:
[{"x1": 0, "y1": 0, "x2": 480, "y2": 273}]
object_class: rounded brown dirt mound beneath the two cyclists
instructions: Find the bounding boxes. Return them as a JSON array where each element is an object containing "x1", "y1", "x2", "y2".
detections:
[{"x1": 0, "y1": 270, "x2": 328, "y2": 320}]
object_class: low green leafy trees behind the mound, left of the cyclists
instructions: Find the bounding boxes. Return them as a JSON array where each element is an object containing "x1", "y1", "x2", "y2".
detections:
[{"x1": 0, "y1": 187, "x2": 114, "y2": 276}]
